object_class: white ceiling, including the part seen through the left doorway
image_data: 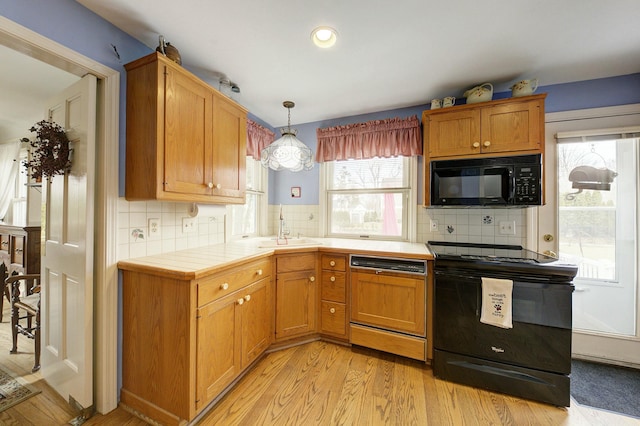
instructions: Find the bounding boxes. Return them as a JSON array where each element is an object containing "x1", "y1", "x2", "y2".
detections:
[{"x1": 0, "y1": 0, "x2": 640, "y2": 142}]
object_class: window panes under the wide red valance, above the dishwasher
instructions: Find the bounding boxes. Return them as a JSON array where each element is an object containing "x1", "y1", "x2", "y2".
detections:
[{"x1": 322, "y1": 156, "x2": 417, "y2": 241}]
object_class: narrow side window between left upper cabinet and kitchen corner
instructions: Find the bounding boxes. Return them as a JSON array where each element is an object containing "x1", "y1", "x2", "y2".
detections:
[{"x1": 227, "y1": 157, "x2": 267, "y2": 240}]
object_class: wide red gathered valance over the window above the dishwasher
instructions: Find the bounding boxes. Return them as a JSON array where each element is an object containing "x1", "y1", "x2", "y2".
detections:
[{"x1": 316, "y1": 115, "x2": 422, "y2": 163}]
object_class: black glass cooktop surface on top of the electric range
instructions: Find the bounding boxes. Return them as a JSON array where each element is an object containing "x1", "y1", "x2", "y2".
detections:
[{"x1": 427, "y1": 241, "x2": 577, "y2": 281}]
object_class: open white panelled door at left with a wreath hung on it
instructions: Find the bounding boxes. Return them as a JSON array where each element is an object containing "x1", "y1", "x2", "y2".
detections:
[{"x1": 41, "y1": 75, "x2": 97, "y2": 408}]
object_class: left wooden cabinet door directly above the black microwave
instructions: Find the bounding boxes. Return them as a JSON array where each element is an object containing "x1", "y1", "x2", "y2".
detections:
[{"x1": 425, "y1": 109, "x2": 480, "y2": 157}]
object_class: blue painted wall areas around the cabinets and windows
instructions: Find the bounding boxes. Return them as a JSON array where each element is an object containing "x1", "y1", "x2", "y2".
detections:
[{"x1": 0, "y1": 0, "x2": 640, "y2": 402}]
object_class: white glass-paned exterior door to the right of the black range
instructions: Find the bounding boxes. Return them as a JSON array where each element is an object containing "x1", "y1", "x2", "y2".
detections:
[{"x1": 557, "y1": 134, "x2": 639, "y2": 336}]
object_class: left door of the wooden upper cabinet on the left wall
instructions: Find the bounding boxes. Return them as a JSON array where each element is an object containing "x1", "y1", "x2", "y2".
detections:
[{"x1": 158, "y1": 65, "x2": 213, "y2": 195}]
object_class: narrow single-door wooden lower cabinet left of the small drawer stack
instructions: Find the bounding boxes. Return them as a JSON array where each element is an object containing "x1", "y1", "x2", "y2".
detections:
[{"x1": 276, "y1": 253, "x2": 318, "y2": 341}]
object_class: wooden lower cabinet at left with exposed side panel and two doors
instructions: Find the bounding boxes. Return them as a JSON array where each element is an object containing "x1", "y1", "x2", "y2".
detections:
[{"x1": 120, "y1": 258, "x2": 274, "y2": 425}]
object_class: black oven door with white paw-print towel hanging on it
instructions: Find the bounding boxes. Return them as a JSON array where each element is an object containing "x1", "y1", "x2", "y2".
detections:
[{"x1": 434, "y1": 268, "x2": 573, "y2": 374}]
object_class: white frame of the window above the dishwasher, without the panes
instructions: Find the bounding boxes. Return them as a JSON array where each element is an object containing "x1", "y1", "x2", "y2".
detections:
[{"x1": 319, "y1": 156, "x2": 418, "y2": 242}]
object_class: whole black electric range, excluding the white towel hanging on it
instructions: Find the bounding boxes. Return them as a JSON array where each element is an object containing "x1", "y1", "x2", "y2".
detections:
[{"x1": 427, "y1": 241, "x2": 577, "y2": 406}]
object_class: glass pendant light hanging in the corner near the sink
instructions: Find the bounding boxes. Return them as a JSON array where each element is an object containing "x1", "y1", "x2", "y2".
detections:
[{"x1": 260, "y1": 101, "x2": 313, "y2": 172}]
